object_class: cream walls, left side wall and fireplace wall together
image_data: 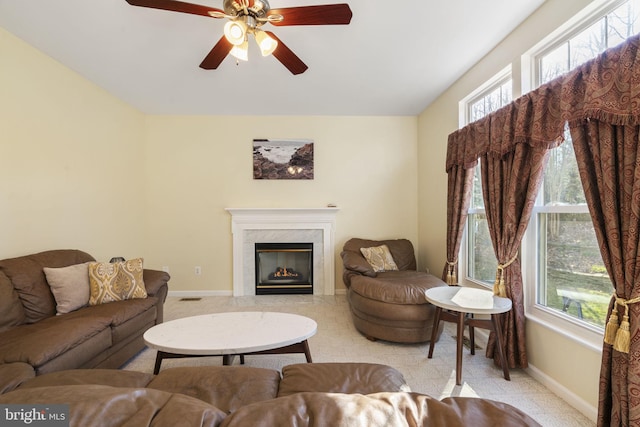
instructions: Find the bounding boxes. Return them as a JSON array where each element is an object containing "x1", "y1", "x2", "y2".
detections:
[{"x1": 0, "y1": 29, "x2": 418, "y2": 293}]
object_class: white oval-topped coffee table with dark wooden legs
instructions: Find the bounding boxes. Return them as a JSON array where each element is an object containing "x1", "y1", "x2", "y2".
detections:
[{"x1": 144, "y1": 311, "x2": 318, "y2": 374}]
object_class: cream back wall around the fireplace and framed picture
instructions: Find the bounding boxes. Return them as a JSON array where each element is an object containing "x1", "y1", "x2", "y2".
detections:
[{"x1": 145, "y1": 116, "x2": 418, "y2": 292}]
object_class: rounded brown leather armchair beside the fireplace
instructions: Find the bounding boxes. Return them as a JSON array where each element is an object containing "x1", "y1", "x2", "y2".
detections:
[{"x1": 341, "y1": 238, "x2": 447, "y2": 343}]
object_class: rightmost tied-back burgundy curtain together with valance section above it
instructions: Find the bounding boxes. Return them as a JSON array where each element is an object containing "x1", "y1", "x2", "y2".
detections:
[{"x1": 563, "y1": 36, "x2": 640, "y2": 426}]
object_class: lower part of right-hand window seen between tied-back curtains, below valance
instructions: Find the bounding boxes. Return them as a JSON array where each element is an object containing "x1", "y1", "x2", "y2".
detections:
[{"x1": 532, "y1": 132, "x2": 612, "y2": 329}]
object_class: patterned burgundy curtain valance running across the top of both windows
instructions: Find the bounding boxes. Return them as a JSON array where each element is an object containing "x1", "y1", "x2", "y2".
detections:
[{"x1": 446, "y1": 35, "x2": 640, "y2": 172}]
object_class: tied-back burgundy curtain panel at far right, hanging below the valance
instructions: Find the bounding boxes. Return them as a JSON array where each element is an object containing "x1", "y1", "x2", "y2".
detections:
[{"x1": 571, "y1": 120, "x2": 640, "y2": 426}]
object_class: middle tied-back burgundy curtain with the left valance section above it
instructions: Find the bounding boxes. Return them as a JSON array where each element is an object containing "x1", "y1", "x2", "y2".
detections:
[{"x1": 447, "y1": 95, "x2": 563, "y2": 368}]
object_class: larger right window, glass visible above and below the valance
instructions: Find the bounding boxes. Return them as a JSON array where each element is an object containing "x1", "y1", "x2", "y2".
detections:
[{"x1": 532, "y1": 1, "x2": 640, "y2": 330}]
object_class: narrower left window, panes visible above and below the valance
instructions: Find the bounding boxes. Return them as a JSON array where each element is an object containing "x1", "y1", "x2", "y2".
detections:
[{"x1": 460, "y1": 68, "x2": 513, "y2": 284}]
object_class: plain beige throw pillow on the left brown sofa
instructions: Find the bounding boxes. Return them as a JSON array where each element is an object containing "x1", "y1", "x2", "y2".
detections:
[{"x1": 43, "y1": 262, "x2": 89, "y2": 315}]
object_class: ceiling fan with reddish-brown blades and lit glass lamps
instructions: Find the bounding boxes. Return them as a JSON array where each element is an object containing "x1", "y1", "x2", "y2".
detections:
[{"x1": 126, "y1": 0, "x2": 352, "y2": 74}]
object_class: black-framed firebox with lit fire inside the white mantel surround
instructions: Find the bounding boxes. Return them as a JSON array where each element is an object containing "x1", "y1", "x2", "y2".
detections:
[{"x1": 255, "y1": 243, "x2": 313, "y2": 295}]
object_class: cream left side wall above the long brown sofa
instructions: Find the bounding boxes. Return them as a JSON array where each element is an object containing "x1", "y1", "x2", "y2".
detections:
[{"x1": 0, "y1": 29, "x2": 144, "y2": 260}]
